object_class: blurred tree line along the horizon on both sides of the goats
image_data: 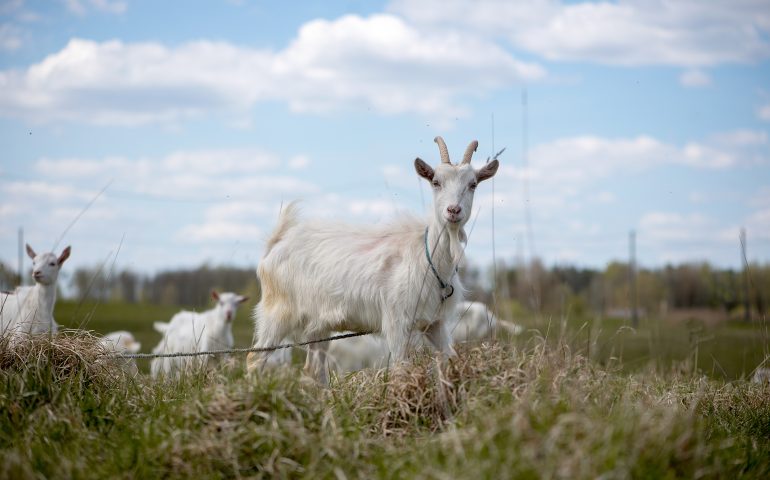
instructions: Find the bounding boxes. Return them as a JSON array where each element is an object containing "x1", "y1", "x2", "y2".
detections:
[{"x1": 0, "y1": 260, "x2": 770, "y2": 317}]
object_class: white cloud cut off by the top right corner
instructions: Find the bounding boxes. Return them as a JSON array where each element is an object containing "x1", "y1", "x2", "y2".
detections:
[{"x1": 390, "y1": 0, "x2": 770, "y2": 67}]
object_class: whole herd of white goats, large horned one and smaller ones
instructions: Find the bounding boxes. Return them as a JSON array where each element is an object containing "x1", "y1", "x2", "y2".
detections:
[{"x1": 0, "y1": 137, "x2": 521, "y2": 384}]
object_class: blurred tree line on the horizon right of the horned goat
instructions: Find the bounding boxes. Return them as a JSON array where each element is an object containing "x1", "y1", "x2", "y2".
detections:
[{"x1": 463, "y1": 260, "x2": 770, "y2": 318}]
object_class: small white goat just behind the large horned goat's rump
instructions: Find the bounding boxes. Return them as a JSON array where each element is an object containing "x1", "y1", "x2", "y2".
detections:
[{"x1": 150, "y1": 291, "x2": 248, "y2": 377}]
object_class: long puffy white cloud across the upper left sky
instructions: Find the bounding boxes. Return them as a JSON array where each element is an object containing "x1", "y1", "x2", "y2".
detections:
[{"x1": 0, "y1": 15, "x2": 545, "y2": 125}]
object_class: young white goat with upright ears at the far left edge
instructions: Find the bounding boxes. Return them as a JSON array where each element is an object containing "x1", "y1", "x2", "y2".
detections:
[{"x1": 0, "y1": 245, "x2": 72, "y2": 336}]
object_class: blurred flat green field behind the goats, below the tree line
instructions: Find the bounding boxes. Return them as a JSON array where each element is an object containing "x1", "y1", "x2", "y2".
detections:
[{"x1": 54, "y1": 301, "x2": 770, "y2": 380}]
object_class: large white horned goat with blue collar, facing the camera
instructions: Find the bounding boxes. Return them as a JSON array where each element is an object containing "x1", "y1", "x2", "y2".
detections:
[{"x1": 248, "y1": 137, "x2": 498, "y2": 384}]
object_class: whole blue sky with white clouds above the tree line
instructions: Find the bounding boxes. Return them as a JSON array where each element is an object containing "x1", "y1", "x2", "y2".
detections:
[{"x1": 0, "y1": 0, "x2": 770, "y2": 282}]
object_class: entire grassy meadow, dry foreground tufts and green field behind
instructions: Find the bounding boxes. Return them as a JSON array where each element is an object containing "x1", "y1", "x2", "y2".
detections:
[{"x1": 0, "y1": 302, "x2": 770, "y2": 479}]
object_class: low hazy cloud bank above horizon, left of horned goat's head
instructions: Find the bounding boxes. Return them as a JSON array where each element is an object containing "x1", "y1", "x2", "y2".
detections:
[{"x1": 0, "y1": 148, "x2": 328, "y2": 268}]
